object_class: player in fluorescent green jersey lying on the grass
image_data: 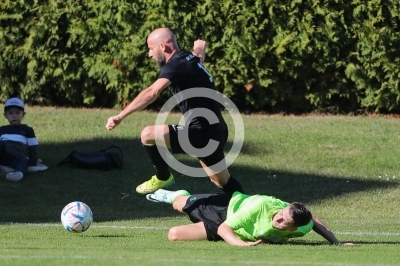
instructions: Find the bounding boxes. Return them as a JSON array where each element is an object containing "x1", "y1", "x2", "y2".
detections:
[{"x1": 146, "y1": 189, "x2": 353, "y2": 246}]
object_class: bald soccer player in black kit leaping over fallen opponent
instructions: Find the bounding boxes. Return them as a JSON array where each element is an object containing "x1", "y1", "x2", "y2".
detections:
[{"x1": 106, "y1": 28, "x2": 244, "y2": 194}]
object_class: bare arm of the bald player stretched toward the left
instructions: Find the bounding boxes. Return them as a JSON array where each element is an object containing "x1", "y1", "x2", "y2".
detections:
[{"x1": 106, "y1": 78, "x2": 171, "y2": 130}]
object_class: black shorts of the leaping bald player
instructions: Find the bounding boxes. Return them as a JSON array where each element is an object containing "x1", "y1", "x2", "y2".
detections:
[{"x1": 168, "y1": 125, "x2": 228, "y2": 166}]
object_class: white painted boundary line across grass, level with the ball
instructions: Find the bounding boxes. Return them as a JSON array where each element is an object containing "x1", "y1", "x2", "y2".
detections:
[{"x1": 0, "y1": 223, "x2": 400, "y2": 237}]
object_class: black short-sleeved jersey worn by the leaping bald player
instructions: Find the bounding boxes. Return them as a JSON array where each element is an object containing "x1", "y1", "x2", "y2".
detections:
[{"x1": 159, "y1": 51, "x2": 226, "y2": 131}]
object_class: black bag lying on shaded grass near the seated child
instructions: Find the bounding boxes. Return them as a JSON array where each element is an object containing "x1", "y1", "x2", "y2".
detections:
[{"x1": 58, "y1": 146, "x2": 123, "y2": 171}]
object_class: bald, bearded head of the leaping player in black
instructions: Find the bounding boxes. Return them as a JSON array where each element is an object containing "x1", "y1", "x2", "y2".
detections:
[{"x1": 147, "y1": 28, "x2": 179, "y2": 67}]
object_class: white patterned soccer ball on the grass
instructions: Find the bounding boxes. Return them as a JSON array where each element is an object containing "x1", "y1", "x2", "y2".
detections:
[{"x1": 61, "y1": 201, "x2": 93, "y2": 233}]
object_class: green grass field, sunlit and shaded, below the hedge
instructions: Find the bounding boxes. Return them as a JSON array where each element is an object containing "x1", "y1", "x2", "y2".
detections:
[{"x1": 0, "y1": 107, "x2": 400, "y2": 266}]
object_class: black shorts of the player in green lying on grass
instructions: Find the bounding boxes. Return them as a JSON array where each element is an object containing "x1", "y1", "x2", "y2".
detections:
[{"x1": 182, "y1": 193, "x2": 232, "y2": 241}]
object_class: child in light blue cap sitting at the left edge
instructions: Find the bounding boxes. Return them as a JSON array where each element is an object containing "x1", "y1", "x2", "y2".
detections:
[{"x1": 0, "y1": 98, "x2": 39, "y2": 181}]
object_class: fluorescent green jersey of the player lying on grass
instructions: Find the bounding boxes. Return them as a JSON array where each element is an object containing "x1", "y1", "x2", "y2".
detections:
[{"x1": 225, "y1": 192, "x2": 313, "y2": 243}]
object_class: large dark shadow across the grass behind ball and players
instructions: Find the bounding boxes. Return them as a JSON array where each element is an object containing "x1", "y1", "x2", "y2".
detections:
[{"x1": 0, "y1": 139, "x2": 395, "y2": 223}]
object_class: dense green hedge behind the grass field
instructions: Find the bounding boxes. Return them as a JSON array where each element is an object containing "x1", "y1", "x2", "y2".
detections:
[{"x1": 0, "y1": 0, "x2": 400, "y2": 112}]
